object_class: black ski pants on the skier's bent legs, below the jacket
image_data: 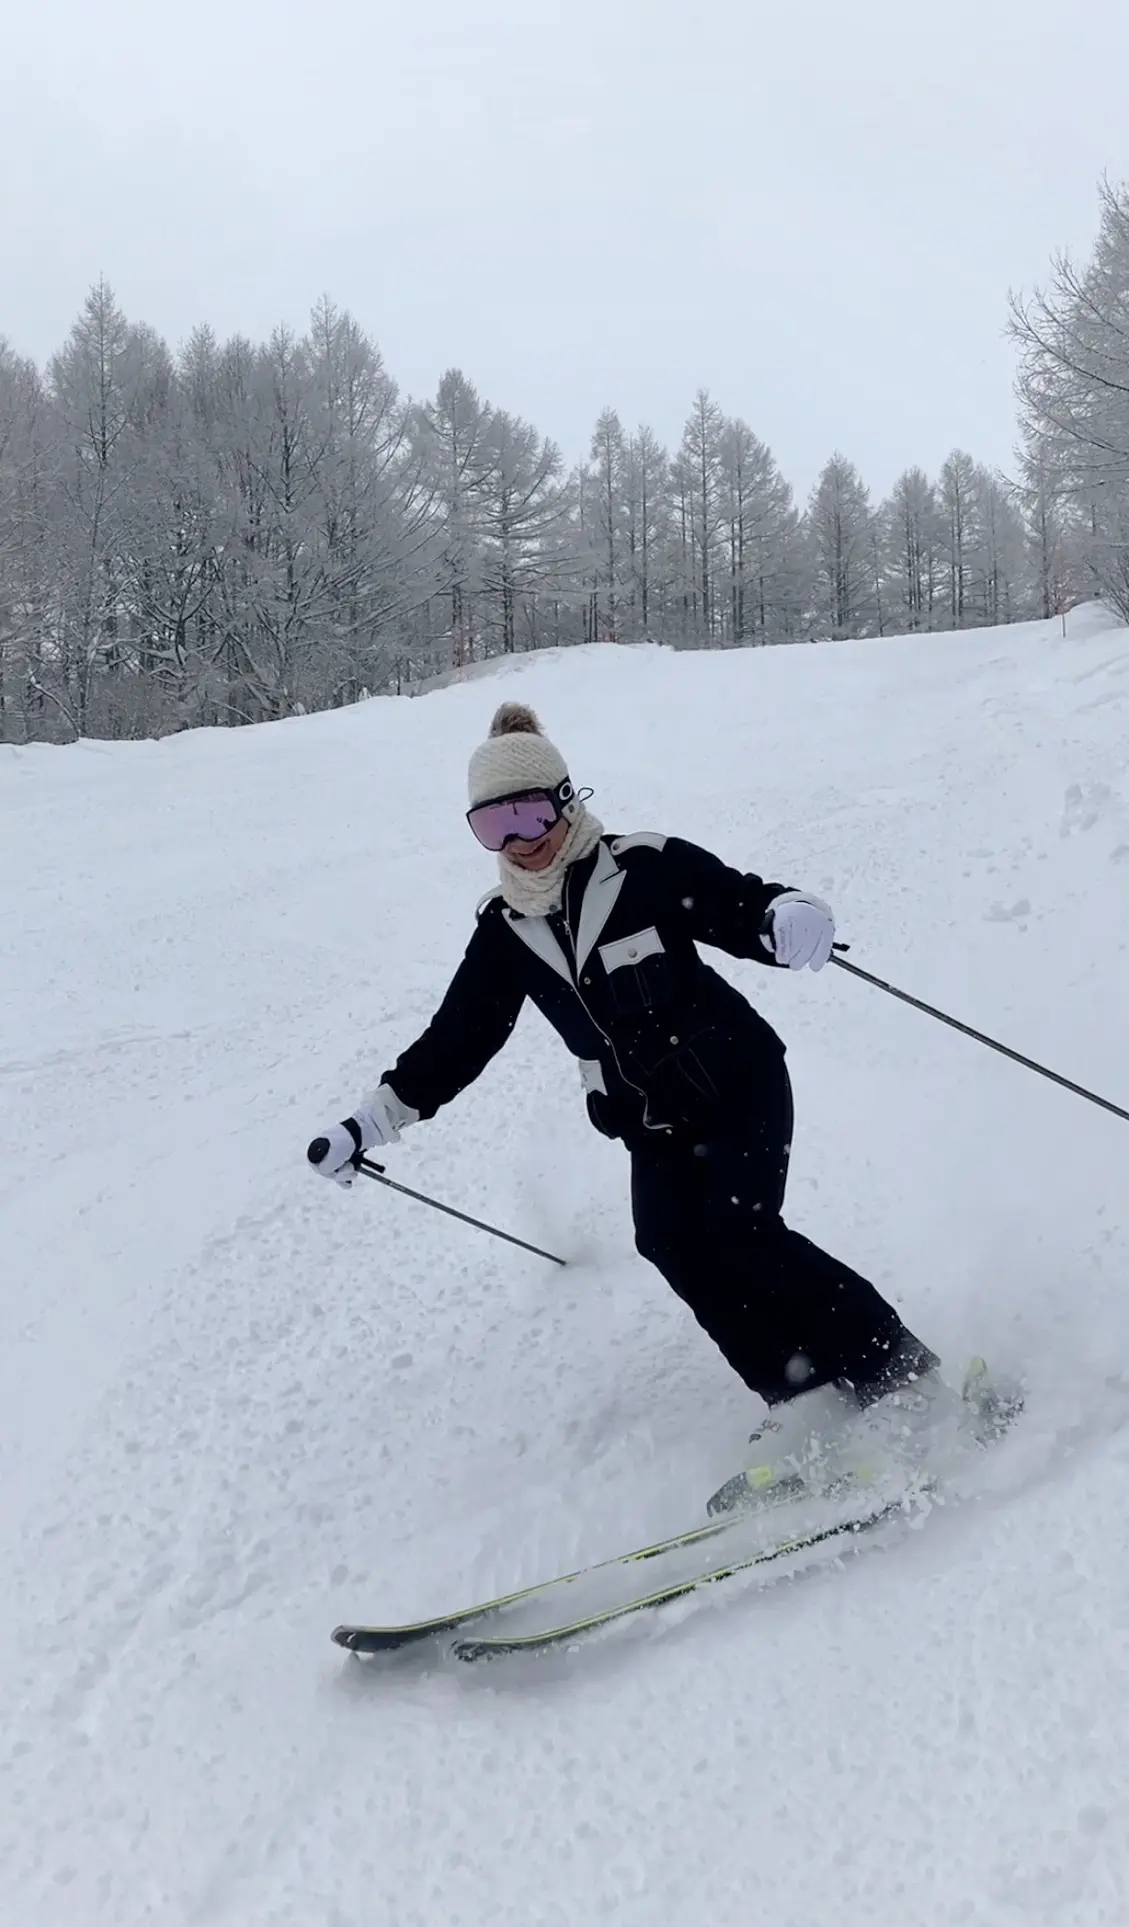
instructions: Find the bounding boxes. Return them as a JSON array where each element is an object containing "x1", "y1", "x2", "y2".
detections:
[{"x1": 628, "y1": 1058, "x2": 924, "y2": 1405}]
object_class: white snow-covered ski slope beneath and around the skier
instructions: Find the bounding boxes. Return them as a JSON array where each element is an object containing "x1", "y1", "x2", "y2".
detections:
[{"x1": 0, "y1": 611, "x2": 1129, "y2": 1927}]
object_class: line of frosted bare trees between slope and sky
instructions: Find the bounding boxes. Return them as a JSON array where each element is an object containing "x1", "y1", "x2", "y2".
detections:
[{"x1": 0, "y1": 187, "x2": 1129, "y2": 742}]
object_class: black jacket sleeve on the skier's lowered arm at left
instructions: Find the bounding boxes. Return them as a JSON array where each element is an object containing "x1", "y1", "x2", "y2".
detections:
[{"x1": 383, "y1": 902, "x2": 526, "y2": 1118}]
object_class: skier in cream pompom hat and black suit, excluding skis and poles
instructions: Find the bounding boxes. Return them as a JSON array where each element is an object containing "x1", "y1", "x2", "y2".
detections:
[{"x1": 308, "y1": 703, "x2": 940, "y2": 1484}]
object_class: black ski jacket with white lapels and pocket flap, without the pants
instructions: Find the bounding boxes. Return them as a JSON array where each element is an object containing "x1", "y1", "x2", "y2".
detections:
[{"x1": 383, "y1": 834, "x2": 784, "y2": 1143}]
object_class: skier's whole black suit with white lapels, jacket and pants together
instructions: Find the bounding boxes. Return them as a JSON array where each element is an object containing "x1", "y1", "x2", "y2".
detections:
[{"x1": 383, "y1": 834, "x2": 932, "y2": 1403}]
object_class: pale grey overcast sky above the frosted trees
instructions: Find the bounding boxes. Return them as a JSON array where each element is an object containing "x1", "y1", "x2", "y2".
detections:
[{"x1": 0, "y1": 0, "x2": 1129, "y2": 493}]
